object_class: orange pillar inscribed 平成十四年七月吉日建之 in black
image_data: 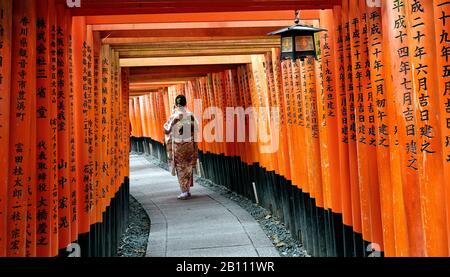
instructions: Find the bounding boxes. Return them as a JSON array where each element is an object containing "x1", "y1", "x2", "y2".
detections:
[{"x1": 382, "y1": 0, "x2": 424, "y2": 255}]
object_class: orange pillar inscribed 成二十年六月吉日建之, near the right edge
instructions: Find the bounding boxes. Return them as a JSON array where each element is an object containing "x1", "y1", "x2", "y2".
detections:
[{"x1": 405, "y1": 0, "x2": 448, "y2": 256}]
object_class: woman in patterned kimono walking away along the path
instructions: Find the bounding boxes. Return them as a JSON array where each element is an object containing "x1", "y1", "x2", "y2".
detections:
[{"x1": 164, "y1": 95, "x2": 198, "y2": 200}]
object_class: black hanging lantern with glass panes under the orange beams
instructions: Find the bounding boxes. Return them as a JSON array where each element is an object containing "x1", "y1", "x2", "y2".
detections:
[{"x1": 269, "y1": 11, "x2": 326, "y2": 60}]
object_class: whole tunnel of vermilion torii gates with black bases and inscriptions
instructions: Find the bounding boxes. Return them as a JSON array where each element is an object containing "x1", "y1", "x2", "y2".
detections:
[{"x1": 0, "y1": 0, "x2": 450, "y2": 257}]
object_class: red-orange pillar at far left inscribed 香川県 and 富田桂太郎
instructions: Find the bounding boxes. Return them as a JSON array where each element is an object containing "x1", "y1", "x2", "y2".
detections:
[{"x1": 7, "y1": 1, "x2": 36, "y2": 256}]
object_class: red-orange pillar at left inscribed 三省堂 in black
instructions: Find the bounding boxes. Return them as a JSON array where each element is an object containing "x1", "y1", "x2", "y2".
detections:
[{"x1": 34, "y1": 0, "x2": 59, "y2": 257}]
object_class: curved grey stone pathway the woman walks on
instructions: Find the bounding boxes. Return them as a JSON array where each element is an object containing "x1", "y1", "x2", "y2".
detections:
[{"x1": 130, "y1": 155, "x2": 279, "y2": 257}]
